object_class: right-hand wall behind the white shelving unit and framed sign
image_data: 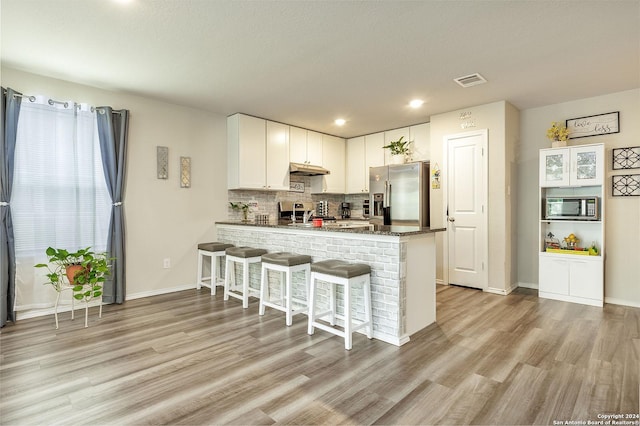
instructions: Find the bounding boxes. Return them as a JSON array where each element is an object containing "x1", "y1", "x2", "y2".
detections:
[{"x1": 518, "y1": 89, "x2": 640, "y2": 306}]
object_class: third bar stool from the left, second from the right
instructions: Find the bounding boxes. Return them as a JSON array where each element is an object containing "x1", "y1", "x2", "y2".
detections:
[{"x1": 258, "y1": 252, "x2": 311, "y2": 326}]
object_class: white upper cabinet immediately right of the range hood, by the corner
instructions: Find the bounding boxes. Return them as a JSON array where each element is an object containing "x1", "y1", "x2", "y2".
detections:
[{"x1": 311, "y1": 134, "x2": 346, "y2": 194}]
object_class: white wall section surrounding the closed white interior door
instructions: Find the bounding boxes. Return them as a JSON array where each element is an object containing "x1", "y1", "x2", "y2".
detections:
[{"x1": 431, "y1": 101, "x2": 519, "y2": 294}]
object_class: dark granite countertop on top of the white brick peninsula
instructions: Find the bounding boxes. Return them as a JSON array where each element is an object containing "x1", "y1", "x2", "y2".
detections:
[{"x1": 216, "y1": 221, "x2": 446, "y2": 236}]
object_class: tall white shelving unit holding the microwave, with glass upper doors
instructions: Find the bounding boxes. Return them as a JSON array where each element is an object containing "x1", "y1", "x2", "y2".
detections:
[{"x1": 538, "y1": 144, "x2": 606, "y2": 307}]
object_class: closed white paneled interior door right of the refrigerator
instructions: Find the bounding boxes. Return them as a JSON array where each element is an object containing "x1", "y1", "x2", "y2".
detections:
[{"x1": 445, "y1": 129, "x2": 488, "y2": 290}]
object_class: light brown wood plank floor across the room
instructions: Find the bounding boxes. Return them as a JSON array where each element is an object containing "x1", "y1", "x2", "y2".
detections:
[{"x1": 0, "y1": 286, "x2": 640, "y2": 425}]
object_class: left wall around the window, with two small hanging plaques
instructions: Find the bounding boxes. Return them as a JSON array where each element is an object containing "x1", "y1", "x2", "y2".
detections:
[{"x1": 1, "y1": 67, "x2": 227, "y2": 299}]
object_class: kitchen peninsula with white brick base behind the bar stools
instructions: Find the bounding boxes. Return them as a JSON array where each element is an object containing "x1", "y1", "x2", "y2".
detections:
[{"x1": 216, "y1": 222, "x2": 444, "y2": 346}]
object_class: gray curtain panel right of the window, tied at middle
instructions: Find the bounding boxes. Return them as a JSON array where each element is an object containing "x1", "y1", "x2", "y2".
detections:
[{"x1": 96, "y1": 107, "x2": 129, "y2": 303}]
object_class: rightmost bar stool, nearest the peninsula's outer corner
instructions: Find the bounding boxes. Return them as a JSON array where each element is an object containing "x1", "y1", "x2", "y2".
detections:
[{"x1": 307, "y1": 260, "x2": 373, "y2": 350}]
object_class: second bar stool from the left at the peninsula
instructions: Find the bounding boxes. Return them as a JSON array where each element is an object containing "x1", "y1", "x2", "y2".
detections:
[{"x1": 224, "y1": 247, "x2": 267, "y2": 308}]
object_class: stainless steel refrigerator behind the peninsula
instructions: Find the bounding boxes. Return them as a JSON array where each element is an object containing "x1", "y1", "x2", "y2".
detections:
[{"x1": 369, "y1": 162, "x2": 429, "y2": 227}]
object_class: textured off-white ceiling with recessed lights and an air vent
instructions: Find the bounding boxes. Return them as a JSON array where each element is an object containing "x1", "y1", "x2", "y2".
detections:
[{"x1": 0, "y1": 0, "x2": 640, "y2": 137}]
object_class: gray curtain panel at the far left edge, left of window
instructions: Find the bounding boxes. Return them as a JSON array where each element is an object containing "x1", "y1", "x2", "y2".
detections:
[{"x1": 0, "y1": 87, "x2": 22, "y2": 327}]
